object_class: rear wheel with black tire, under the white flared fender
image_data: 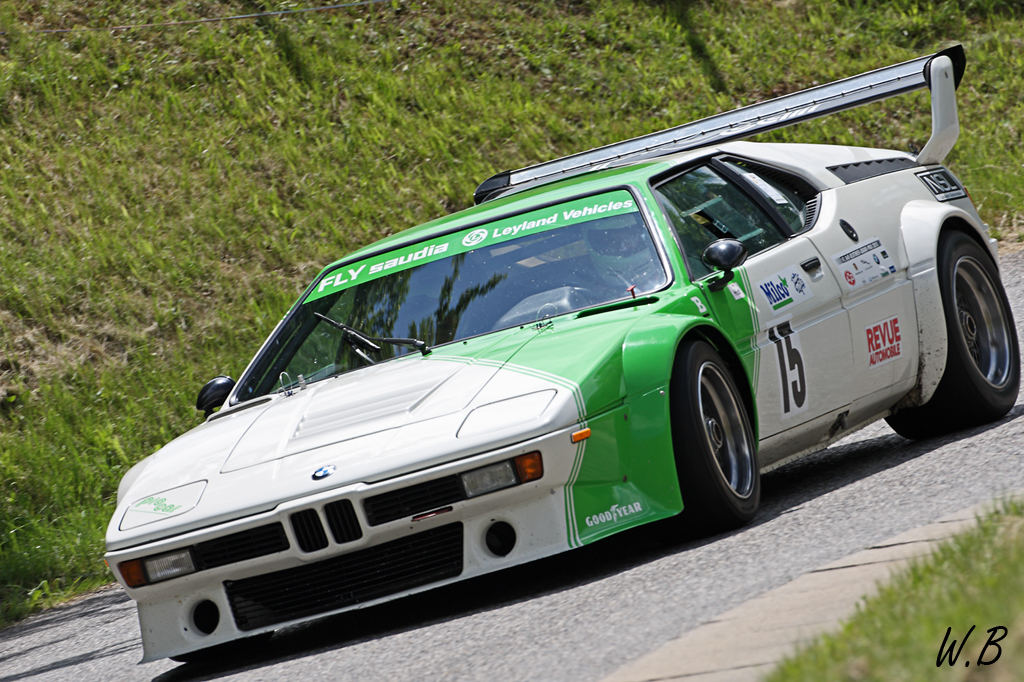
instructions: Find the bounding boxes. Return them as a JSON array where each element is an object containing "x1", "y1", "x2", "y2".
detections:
[{"x1": 886, "y1": 230, "x2": 1021, "y2": 438}]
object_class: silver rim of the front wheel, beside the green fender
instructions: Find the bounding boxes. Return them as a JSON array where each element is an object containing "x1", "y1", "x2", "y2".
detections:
[{"x1": 697, "y1": 363, "x2": 757, "y2": 499}]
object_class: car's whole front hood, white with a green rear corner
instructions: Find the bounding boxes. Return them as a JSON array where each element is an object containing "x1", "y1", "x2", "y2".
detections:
[{"x1": 106, "y1": 315, "x2": 636, "y2": 550}]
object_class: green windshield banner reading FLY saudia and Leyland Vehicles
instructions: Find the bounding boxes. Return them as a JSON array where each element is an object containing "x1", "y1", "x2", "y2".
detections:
[{"x1": 303, "y1": 189, "x2": 639, "y2": 303}]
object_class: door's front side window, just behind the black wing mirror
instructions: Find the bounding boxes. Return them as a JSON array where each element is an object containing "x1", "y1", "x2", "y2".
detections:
[{"x1": 654, "y1": 166, "x2": 786, "y2": 280}]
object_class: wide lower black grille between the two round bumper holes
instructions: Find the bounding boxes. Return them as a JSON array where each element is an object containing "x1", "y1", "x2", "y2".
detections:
[{"x1": 224, "y1": 523, "x2": 463, "y2": 630}]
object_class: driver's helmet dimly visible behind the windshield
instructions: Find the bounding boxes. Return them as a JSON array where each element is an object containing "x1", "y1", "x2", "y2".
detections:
[{"x1": 585, "y1": 215, "x2": 656, "y2": 289}]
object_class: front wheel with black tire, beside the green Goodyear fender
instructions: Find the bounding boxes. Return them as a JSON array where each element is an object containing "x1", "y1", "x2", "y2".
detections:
[{"x1": 670, "y1": 341, "x2": 761, "y2": 536}]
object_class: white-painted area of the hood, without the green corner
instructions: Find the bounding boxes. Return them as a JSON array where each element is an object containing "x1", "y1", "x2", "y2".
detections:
[{"x1": 106, "y1": 355, "x2": 580, "y2": 553}]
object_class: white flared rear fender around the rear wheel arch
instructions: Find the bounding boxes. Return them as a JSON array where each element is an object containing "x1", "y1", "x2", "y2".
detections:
[{"x1": 894, "y1": 200, "x2": 998, "y2": 405}]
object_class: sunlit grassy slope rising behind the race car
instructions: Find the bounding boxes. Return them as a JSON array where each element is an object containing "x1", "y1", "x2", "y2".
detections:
[{"x1": 0, "y1": 0, "x2": 1024, "y2": 623}]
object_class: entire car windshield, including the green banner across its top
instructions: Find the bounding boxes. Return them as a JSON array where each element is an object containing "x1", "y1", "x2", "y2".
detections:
[{"x1": 238, "y1": 189, "x2": 668, "y2": 400}]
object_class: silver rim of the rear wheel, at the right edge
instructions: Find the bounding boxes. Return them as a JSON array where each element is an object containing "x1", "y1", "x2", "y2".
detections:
[{"x1": 953, "y1": 256, "x2": 1012, "y2": 388}]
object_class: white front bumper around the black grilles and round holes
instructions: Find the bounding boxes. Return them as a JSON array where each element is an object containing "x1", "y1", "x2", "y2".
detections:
[{"x1": 106, "y1": 428, "x2": 577, "y2": 662}]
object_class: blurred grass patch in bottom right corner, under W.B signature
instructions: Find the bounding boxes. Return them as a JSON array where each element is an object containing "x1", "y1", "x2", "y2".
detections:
[{"x1": 766, "y1": 502, "x2": 1024, "y2": 682}]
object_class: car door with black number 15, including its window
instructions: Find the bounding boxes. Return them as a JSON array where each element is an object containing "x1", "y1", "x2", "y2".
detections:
[{"x1": 653, "y1": 160, "x2": 852, "y2": 466}]
